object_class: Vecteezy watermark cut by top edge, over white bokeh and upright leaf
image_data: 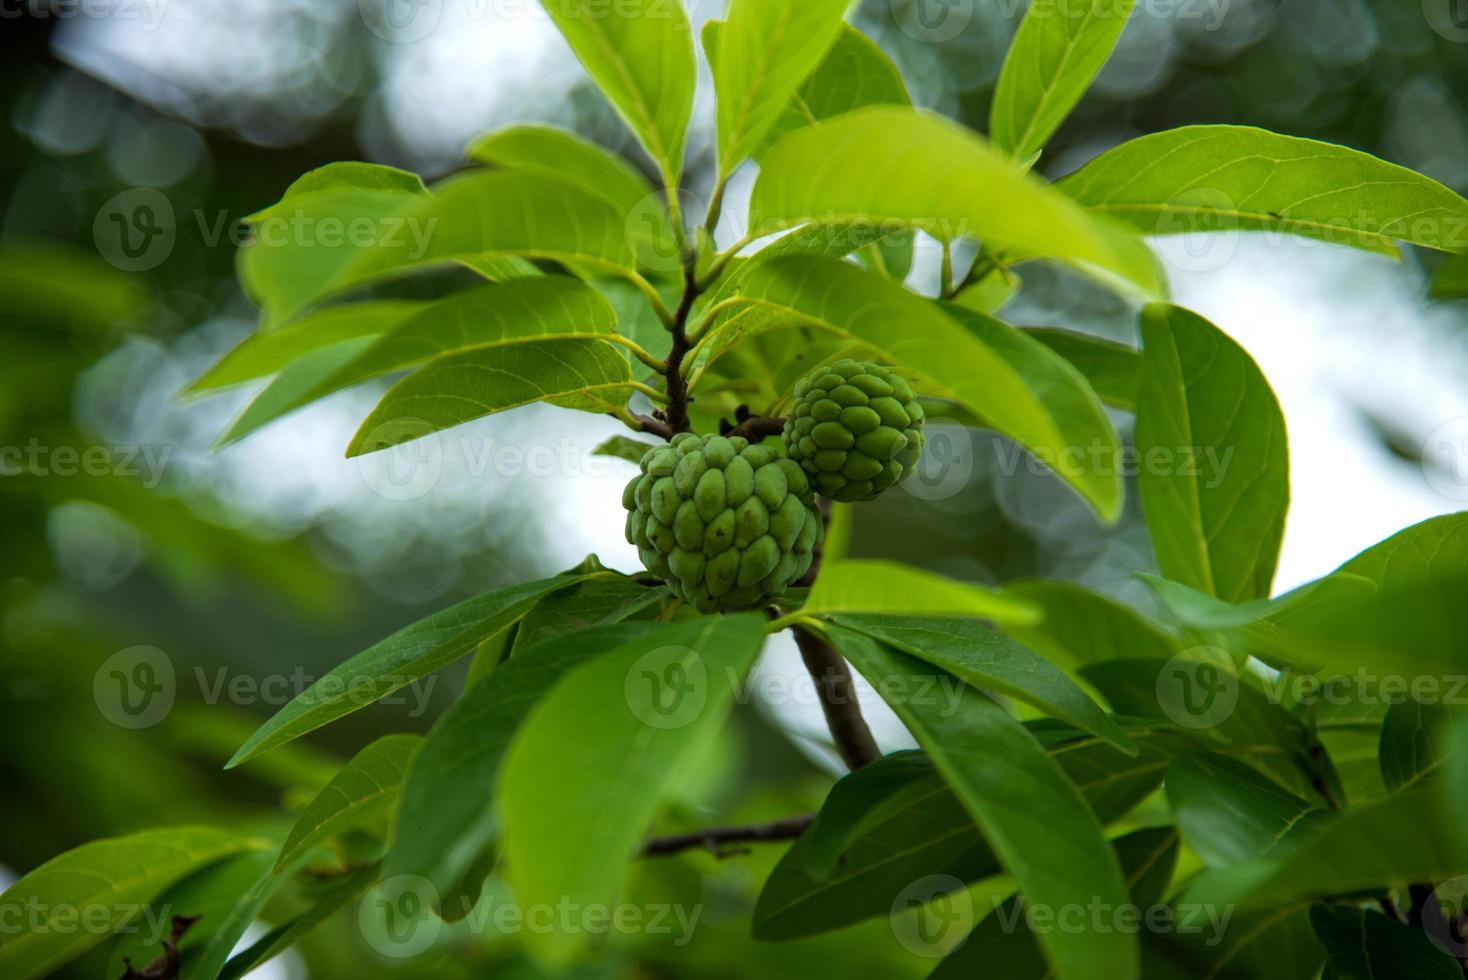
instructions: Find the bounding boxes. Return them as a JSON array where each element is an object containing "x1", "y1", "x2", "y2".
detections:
[{"x1": 357, "y1": 0, "x2": 687, "y2": 44}]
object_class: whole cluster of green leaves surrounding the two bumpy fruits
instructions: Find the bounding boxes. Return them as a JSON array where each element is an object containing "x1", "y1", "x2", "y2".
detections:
[{"x1": 0, "y1": 0, "x2": 1468, "y2": 980}]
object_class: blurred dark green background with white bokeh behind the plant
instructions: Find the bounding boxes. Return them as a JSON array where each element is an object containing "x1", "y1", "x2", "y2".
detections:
[{"x1": 0, "y1": 0, "x2": 1468, "y2": 977}]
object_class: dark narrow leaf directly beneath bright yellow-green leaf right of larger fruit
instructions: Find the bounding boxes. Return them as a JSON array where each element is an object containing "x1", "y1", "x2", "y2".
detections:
[{"x1": 818, "y1": 613, "x2": 1136, "y2": 753}]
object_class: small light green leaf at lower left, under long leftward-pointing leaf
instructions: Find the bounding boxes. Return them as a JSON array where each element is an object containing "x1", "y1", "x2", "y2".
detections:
[{"x1": 276, "y1": 735, "x2": 423, "y2": 871}]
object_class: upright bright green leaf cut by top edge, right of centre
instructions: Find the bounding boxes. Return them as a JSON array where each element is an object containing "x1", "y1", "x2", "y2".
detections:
[{"x1": 989, "y1": 0, "x2": 1133, "y2": 160}]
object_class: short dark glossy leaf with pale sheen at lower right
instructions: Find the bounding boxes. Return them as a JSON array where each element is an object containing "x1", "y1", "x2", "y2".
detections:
[{"x1": 1167, "y1": 756, "x2": 1329, "y2": 867}]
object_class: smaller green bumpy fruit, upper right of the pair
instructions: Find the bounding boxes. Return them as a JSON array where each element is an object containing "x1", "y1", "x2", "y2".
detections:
[{"x1": 781, "y1": 359, "x2": 923, "y2": 502}]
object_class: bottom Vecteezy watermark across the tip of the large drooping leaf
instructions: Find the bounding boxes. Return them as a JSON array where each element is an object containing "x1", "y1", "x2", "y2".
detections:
[{"x1": 357, "y1": 874, "x2": 703, "y2": 959}]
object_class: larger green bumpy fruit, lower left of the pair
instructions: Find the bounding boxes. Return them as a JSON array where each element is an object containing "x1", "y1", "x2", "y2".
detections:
[{"x1": 622, "y1": 433, "x2": 824, "y2": 613}]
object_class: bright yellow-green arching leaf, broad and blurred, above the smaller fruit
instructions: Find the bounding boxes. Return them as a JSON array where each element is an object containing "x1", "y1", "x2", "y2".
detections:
[{"x1": 749, "y1": 106, "x2": 1161, "y2": 295}]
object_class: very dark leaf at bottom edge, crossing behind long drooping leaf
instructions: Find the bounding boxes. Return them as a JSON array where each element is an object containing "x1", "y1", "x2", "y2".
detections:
[{"x1": 928, "y1": 827, "x2": 1177, "y2": 980}]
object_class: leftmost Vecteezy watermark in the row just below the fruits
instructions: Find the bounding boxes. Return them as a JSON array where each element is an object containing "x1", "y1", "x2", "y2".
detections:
[{"x1": 92, "y1": 646, "x2": 437, "y2": 729}]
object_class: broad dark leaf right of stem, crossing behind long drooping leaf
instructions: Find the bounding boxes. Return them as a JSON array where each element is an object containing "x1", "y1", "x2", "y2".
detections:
[{"x1": 755, "y1": 726, "x2": 1193, "y2": 940}]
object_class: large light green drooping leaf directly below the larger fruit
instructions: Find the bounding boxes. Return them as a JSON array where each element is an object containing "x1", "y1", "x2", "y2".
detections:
[{"x1": 499, "y1": 613, "x2": 762, "y2": 962}]
